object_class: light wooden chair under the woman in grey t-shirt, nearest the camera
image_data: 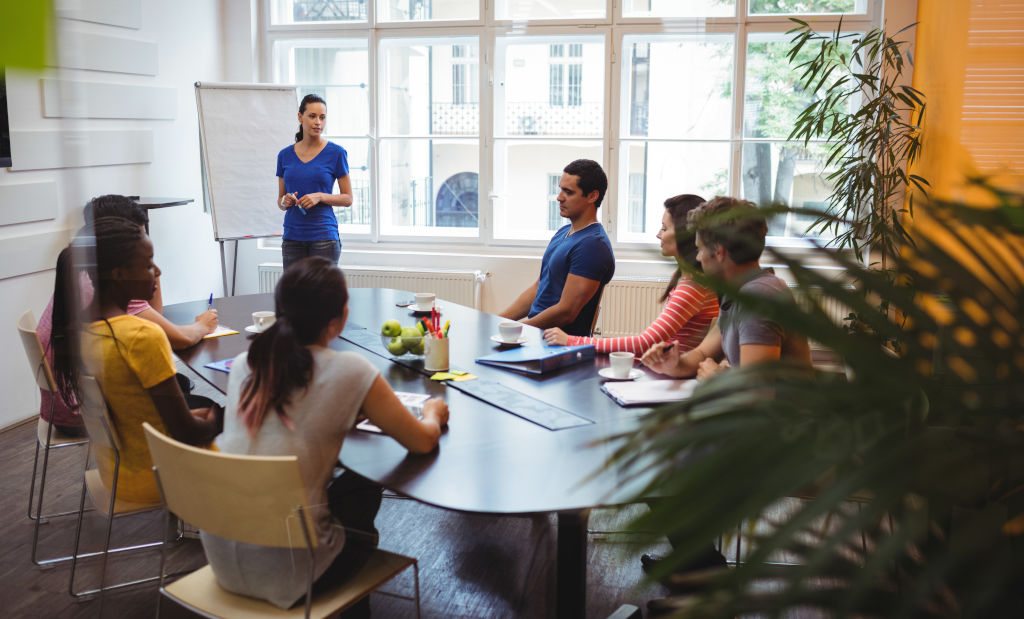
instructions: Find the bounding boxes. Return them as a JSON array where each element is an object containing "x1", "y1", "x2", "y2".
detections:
[{"x1": 142, "y1": 423, "x2": 420, "y2": 618}]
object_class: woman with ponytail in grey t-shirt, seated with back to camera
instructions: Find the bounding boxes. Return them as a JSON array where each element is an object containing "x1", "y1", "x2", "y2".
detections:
[{"x1": 202, "y1": 257, "x2": 449, "y2": 617}]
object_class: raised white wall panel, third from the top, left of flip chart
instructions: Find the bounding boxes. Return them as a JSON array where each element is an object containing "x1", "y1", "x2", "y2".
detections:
[{"x1": 39, "y1": 78, "x2": 177, "y2": 120}]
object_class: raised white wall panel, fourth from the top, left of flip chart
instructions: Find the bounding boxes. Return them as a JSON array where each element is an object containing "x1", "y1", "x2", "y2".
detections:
[{"x1": 10, "y1": 129, "x2": 153, "y2": 171}]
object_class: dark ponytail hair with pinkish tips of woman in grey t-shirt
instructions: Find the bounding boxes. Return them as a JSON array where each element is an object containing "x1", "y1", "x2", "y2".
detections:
[{"x1": 239, "y1": 256, "x2": 348, "y2": 436}]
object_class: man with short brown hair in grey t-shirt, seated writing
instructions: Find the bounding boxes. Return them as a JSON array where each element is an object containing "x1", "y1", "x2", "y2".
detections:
[{"x1": 641, "y1": 196, "x2": 811, "y2": 379}]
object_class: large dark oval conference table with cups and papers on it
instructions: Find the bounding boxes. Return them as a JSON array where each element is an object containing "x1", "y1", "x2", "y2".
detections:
[{"x1": 164, "y1": 288, "x2": 647, "y2": 618}]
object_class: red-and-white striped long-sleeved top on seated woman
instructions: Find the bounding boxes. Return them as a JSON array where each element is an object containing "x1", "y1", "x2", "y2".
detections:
[{"x1": 568, "y1": 279, "x2": 718, "y2": 356}]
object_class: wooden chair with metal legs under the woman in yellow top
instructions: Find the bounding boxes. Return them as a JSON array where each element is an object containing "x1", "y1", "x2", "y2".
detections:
[{"x1": 68, "y1": 376, "x2": 164, "y2": 597}]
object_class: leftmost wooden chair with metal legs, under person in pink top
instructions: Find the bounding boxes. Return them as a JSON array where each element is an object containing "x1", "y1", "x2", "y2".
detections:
[{"x1": 17, "y1": 310, "x2": 89, "y2": 566}]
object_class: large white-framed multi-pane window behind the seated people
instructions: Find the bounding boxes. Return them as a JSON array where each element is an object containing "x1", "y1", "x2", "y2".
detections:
[{"x1": 265, "y1": 0, "x2": 881, "y2": 249}]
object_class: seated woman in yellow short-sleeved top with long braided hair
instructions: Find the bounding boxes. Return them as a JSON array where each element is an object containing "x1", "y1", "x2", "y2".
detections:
[{"x1": 53, "y1": 217, "x2": 220, "y2": 502}]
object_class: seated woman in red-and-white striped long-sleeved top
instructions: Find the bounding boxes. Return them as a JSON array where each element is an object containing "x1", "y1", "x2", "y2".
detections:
[{"x1": 544, "y1": 194, "x2": 718, "y2": 356}]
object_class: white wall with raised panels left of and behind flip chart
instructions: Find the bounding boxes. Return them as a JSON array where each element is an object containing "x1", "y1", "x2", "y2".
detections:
[{"x1": 0, "y1": 0, "x2": 232, "y2": 427}]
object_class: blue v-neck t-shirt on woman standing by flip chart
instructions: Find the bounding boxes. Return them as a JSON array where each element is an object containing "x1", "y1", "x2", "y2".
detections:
[{"x1": 278, "y1": 141, "x2": 348, "y2": 241}]
